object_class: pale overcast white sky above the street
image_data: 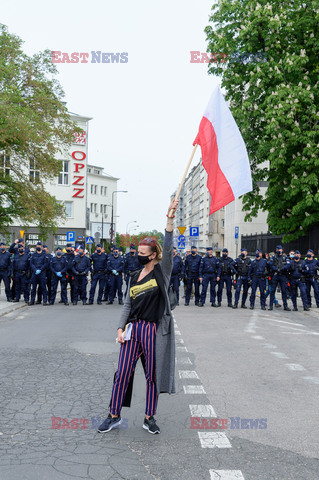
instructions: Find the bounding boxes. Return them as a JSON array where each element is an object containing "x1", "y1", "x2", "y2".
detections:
[{"x1": 1, "y1": 0, "x2": 220, "y2": 233}]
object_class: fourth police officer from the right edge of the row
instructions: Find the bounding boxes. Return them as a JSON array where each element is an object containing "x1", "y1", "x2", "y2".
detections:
[{"x1": 248, "y1": 249, "x2": 269, "y2": 310}]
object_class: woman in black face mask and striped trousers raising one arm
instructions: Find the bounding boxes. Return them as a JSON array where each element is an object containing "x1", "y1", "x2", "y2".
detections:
[{"x1": 98, "y1": 200, "x2": 178, "y2": 434}]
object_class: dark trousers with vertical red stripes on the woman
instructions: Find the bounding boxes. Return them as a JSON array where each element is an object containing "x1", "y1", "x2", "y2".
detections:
[{"x1": 110, "y1": 320, "x2": 158, "y2": 416}]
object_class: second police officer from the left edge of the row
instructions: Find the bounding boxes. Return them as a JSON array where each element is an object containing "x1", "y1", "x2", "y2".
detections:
[{"x1": 12, "y1": 244, "x2": 30, "y2": 303}]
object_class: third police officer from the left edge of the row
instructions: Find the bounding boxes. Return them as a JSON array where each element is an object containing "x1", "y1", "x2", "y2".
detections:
[{"x1": 29, "y1": 242, "x2": 48, "y2": 305}]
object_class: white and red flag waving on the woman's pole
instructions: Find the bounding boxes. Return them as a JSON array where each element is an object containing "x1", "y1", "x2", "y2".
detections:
[{"x1": 193, "y1": 87, "x2": 252, "y2": 215}]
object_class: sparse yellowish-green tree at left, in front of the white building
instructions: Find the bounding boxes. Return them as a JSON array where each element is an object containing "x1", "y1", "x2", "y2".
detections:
[{"x1": 0, "y1": 24, "x2": 79, "y2": 238}]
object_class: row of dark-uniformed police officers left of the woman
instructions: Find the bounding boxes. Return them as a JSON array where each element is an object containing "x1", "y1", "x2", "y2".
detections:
[{"x1": 0, "y1": 238, "x2": 142, "y2": 305}]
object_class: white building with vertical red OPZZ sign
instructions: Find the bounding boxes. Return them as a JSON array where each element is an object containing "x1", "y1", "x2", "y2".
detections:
[{"x1": 3, "y1": 113, "x2": 118, "y2": 251}]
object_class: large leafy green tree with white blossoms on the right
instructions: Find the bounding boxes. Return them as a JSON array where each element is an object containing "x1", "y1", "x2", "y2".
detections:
[{"x1": 205, "y1": 0, "x2": 319, "y2": 241}]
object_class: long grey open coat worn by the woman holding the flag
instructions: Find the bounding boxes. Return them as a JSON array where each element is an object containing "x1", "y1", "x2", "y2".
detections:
[{"x1": 119, "y1": 231, "x2": 175, "y2": 394}]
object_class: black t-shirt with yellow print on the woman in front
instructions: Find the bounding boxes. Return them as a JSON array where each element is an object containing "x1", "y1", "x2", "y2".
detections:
[{"x1": 130, "y1": 270, "x2": 160, "y2": 322}]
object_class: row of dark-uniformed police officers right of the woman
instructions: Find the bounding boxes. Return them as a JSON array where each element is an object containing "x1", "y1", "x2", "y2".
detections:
[{"x1": 171, "y1": 245, "x2": 319, "y2": 311}]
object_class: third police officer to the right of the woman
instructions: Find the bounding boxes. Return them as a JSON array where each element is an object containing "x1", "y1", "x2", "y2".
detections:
[{"x1": 198, "y1": 247, "x2": 220, "y2": 307}]
